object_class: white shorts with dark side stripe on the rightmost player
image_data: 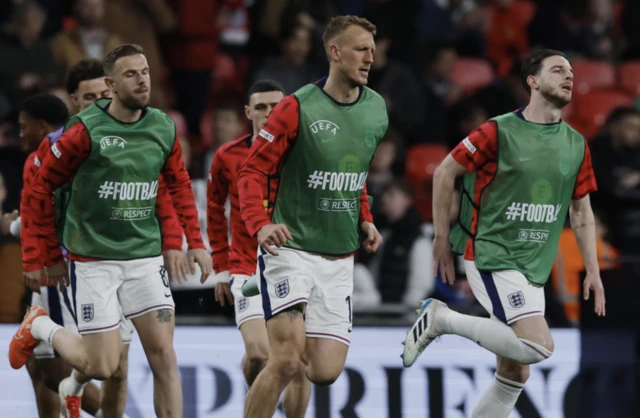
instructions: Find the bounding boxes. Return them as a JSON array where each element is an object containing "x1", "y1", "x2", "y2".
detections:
[{"x1": 464, "y1": 260, "x2": 545, "y2": 325}]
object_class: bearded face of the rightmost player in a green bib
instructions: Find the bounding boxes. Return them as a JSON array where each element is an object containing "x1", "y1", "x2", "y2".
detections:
[{"x1": 537, "y1": 56, "x2": 573, "y2": 108}]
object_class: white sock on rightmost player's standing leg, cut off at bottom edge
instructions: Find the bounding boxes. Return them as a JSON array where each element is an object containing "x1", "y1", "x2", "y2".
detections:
[{"x1": 471, "y1": 374, "x2": 524, "y2": 418}]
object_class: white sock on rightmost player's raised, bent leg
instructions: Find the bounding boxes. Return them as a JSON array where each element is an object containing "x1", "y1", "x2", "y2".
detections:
[{"x1": 436, "y1": 309, "x2": 551, "y2": 364}]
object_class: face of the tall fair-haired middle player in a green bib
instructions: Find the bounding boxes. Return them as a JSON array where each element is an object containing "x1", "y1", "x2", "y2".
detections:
[{"x1": 335, "y1": 25, "x2": 376, "y2": 86}]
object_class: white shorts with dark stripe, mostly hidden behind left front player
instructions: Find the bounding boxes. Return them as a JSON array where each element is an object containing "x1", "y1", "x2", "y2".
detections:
[{"x1": 31, "y1": 283, "x2": 78, "y2": 359}]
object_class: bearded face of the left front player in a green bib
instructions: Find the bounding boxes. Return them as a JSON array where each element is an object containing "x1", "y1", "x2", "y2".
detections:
[{"x1": 107, "y1": 54, "x2": 151, "y2": 110}]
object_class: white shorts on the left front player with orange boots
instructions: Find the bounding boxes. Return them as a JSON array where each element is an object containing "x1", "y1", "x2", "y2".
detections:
[{"x1": 71, "y1": 256, "x2": 175, "y2": 339}]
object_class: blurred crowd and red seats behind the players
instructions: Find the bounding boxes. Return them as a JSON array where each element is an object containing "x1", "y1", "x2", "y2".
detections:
[{"x1": 0, "y1": 0, "x2": 640, "y2": 334}]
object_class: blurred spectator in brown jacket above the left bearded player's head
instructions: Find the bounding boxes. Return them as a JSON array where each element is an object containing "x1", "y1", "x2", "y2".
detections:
[{"x1": 51, "y1": 0, "x2": 123, "y2": 73}]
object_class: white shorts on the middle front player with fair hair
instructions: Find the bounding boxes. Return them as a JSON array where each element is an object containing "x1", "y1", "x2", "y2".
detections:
[{"x1": 258, "y1": 248, "x2": 353, "y2": 345}]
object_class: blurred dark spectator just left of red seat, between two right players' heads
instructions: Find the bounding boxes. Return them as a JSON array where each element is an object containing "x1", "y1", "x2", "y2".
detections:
[{"x1": 418, "y1": 41, "x2": 464, "y2": 142}]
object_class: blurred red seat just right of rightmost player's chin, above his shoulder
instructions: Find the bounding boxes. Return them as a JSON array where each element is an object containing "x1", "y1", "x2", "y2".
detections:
[{"x1": 572, "y1": 89, "x2": 633, "y2": 138}]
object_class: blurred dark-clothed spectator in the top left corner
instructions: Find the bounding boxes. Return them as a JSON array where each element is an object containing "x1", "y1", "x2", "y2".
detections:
[{"x1": 0, "y1": 0, "x2": 60, "y2": 104}]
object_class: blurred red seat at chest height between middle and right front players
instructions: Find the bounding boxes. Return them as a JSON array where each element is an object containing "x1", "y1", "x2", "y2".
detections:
[{"x1": 405, "y1": 144, "x2": 449, "y2": 222}]
